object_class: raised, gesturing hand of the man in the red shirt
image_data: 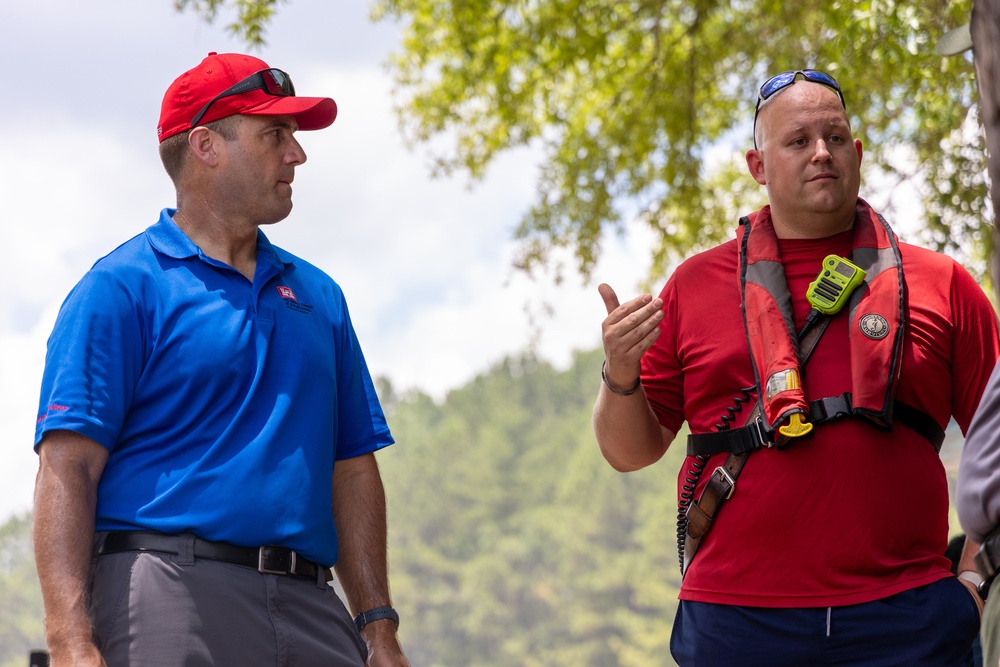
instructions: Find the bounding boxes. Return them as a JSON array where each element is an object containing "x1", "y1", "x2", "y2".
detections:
[{"x1": 597, "y1": 283, "x2": 663, "y2": 391}]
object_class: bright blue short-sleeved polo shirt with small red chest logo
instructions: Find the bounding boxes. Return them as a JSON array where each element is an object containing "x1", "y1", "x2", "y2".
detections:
[{"x1": 35, "y1": 209, "x2": 393, "y2": 565}]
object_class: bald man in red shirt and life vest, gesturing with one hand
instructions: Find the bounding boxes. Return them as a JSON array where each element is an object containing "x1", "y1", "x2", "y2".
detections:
[{"x1": 594, "y1": 70, "x2": 1000, "y2": 666}]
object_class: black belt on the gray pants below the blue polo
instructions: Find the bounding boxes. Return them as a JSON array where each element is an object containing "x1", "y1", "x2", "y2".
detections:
[{"x1": 97, "y1": 530, "x2": 333, "y2": 581}]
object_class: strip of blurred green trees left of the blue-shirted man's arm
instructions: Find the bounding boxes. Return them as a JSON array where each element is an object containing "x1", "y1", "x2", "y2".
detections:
[{"x1": 0, "y1": 516, "x2": 45, "y2": 667}]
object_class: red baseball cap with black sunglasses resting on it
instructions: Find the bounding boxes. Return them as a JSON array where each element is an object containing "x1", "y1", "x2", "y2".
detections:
[{"x1": 156, "y1": 51, "x2": 337, "y2": 142}]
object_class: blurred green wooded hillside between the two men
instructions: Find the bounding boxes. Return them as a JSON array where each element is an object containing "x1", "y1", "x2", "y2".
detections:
[{"x1": 380, "y1": 352, "x2": 683, "y2": 667}]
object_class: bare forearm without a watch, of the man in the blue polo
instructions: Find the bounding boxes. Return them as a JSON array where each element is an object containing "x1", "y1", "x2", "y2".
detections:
[{"x1": 32, "y1": 436, "x2": 103, "y2": 664}]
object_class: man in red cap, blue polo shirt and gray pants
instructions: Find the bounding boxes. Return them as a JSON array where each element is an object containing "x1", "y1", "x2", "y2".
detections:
[{"x1": 34, "y1": 53, "x2": 407, "y2": 667}]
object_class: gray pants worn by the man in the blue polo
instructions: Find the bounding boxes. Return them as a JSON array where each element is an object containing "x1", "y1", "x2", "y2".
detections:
[{"x1": 91, "y1": 538, "x2": 367, "y2": 667}]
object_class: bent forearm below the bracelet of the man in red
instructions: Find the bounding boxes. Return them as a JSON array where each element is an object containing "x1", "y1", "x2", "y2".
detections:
[{"x1": 594, "y1": 383, "x2": 674, "y2": 472}]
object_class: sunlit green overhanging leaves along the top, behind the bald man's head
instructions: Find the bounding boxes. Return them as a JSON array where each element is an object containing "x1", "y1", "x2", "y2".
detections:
[{"x1": 177, "y1": 0, "x2": 992, "y2": 276}]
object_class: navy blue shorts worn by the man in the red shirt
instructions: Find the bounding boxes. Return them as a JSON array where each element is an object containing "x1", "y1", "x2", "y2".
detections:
[{"x1": 670, "y1": 577, "x2": 979, "y2": 667}]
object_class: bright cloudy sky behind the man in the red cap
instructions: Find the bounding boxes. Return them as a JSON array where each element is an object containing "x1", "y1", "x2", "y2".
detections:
[{"x1": 0, "y1": 0, "x2": 648, "y2": 521}]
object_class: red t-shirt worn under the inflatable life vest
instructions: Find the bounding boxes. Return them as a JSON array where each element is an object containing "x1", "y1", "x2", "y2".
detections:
[{"x1": 642, "y1": 231, "x2": 1000, "y2": 607}]
